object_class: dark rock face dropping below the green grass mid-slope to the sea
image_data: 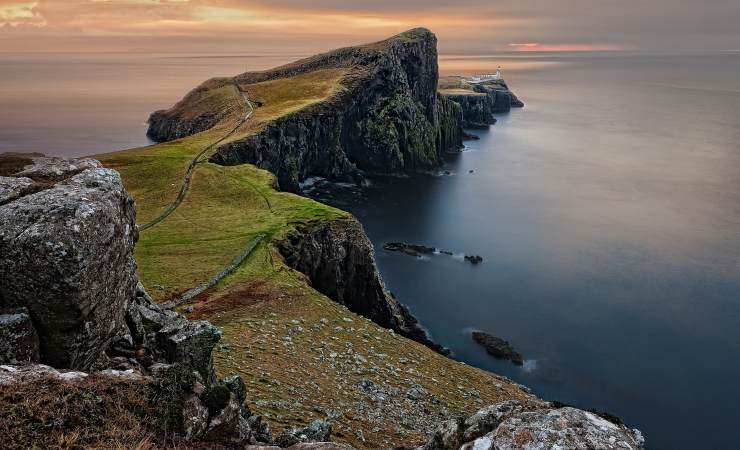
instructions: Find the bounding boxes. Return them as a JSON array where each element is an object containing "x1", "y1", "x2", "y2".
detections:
[{"x1": 277, "y1": 218, "x2": 444, "y2": 351}]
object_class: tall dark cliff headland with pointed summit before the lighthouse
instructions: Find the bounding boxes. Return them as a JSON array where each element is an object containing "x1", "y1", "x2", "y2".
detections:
[{"x1": 149, "y1": 29, "x2": 461, "y2": 191}]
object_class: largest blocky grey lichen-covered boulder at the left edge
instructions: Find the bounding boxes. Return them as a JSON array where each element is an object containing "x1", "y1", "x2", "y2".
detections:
[{"x1": 0, "y1": 159, "x2": 138, "y2": 369}]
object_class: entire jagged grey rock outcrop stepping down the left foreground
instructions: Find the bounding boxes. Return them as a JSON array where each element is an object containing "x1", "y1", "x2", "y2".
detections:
[{"x1": 0, "y1": 157, "x2": 288, "y2": 445}]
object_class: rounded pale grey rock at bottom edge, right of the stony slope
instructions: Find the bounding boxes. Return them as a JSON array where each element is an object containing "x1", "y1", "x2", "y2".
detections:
[{"x1": 422, "y1": 400, "x2": 645, "y2": 450}]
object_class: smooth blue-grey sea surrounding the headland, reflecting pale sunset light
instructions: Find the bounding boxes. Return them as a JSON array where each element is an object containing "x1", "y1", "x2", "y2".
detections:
[{"x1": 0, "y1": 53, "x2": 740, "y2": 449}]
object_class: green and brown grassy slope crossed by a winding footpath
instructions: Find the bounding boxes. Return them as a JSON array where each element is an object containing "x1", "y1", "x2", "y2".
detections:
[{"x1": 98, "y1": 56, "x2": 525, "y2": 448}]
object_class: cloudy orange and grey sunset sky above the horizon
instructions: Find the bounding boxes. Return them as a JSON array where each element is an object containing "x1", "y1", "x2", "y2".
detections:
[{"x1": 0, "y1": 0, "x2": 740, "y2": 55}]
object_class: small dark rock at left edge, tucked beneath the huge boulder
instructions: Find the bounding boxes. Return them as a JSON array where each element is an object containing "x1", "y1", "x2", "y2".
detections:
[{"x1": 0, "y1": 308, "x2": 39, "y2": 364}]
